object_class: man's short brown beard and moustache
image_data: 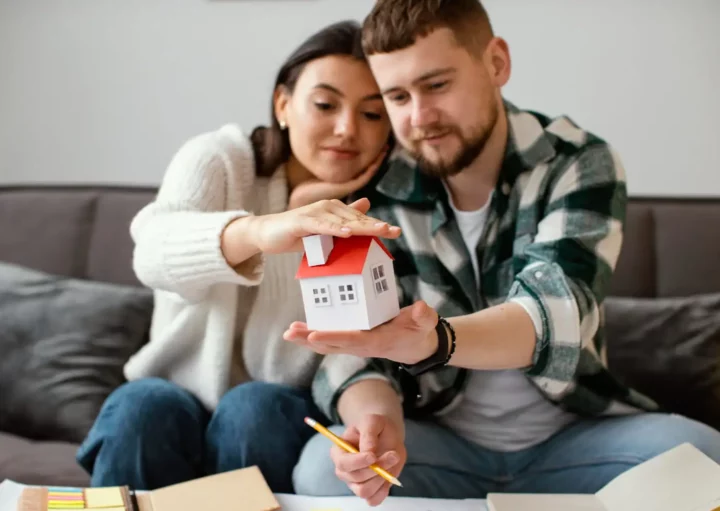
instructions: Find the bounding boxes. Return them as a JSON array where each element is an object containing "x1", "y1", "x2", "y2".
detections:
[{"x1": 410, "y1": 109, "x2": 498, "y2": 178}]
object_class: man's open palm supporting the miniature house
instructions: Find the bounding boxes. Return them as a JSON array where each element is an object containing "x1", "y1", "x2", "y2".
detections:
[{"x1": 283, "y1": 301, "x2": 438, "y2": 364}]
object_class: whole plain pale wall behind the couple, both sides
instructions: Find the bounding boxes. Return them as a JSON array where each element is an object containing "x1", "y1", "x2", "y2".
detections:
[{"x1": 0, "y1": 0, "x2": 720, "y2": 196}]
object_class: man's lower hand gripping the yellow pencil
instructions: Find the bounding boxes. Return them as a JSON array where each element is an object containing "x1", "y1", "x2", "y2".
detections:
[{"x1": 330, "y1": 414, "x2": 407, "y2": 506}]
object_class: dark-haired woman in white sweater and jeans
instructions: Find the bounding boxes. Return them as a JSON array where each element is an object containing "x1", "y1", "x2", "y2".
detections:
[{"x1": 78, "y1": 22, "x2": 399, "y2": 493}]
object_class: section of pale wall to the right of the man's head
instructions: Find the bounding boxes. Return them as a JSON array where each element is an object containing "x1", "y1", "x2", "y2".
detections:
[{"x1": 487, "y1": 0, "x2": 720, "y2": 197}]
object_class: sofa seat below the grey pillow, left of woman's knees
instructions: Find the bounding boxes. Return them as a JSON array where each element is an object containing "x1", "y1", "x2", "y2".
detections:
[{"x1": 0, "y1": 433, "x2": 90, "y2": 487}]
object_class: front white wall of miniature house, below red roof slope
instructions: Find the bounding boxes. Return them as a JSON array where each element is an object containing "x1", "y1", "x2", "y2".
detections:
[{"x1": 300, "y1": 275, "x2": 369, "y2": 330}]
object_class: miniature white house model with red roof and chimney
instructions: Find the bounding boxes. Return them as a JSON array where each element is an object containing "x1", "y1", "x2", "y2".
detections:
[{"x1": 296, "y1": 234, "x2": 400, "y2": 330}]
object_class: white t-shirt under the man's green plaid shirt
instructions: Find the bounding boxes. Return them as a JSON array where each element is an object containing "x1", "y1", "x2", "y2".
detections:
[{"x1": 440, "y1": 185, "x2": 575, "y2": 452}]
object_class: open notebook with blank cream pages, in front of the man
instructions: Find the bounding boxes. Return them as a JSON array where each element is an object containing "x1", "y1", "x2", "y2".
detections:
[{"x1": 487, "y1": 444, "x2": 720, "y2": 511}]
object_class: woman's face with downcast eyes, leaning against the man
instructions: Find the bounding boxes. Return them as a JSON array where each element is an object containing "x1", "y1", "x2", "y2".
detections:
[{"x1": 275, "y1": 55, "x2": 390, "y2": 183}]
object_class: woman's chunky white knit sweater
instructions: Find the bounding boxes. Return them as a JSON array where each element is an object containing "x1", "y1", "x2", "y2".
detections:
[{"x1": 125, "y1": 124, "x2": 320, "y2": 410}]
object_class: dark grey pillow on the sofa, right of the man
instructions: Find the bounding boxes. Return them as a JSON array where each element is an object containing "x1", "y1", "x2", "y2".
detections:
[{"x1": 605, "y1": 294, "x2": 720, "y2": 430}]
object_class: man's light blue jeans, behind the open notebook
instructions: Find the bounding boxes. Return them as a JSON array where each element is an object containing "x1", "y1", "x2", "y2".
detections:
[{"x1": 294, "y1": 414, "x2": 720, "y2": 499}]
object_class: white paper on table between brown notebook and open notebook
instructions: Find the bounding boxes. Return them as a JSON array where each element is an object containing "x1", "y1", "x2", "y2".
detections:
[{"x1": 275, "y1": 494, "x2": 487, "y2": 511}]
